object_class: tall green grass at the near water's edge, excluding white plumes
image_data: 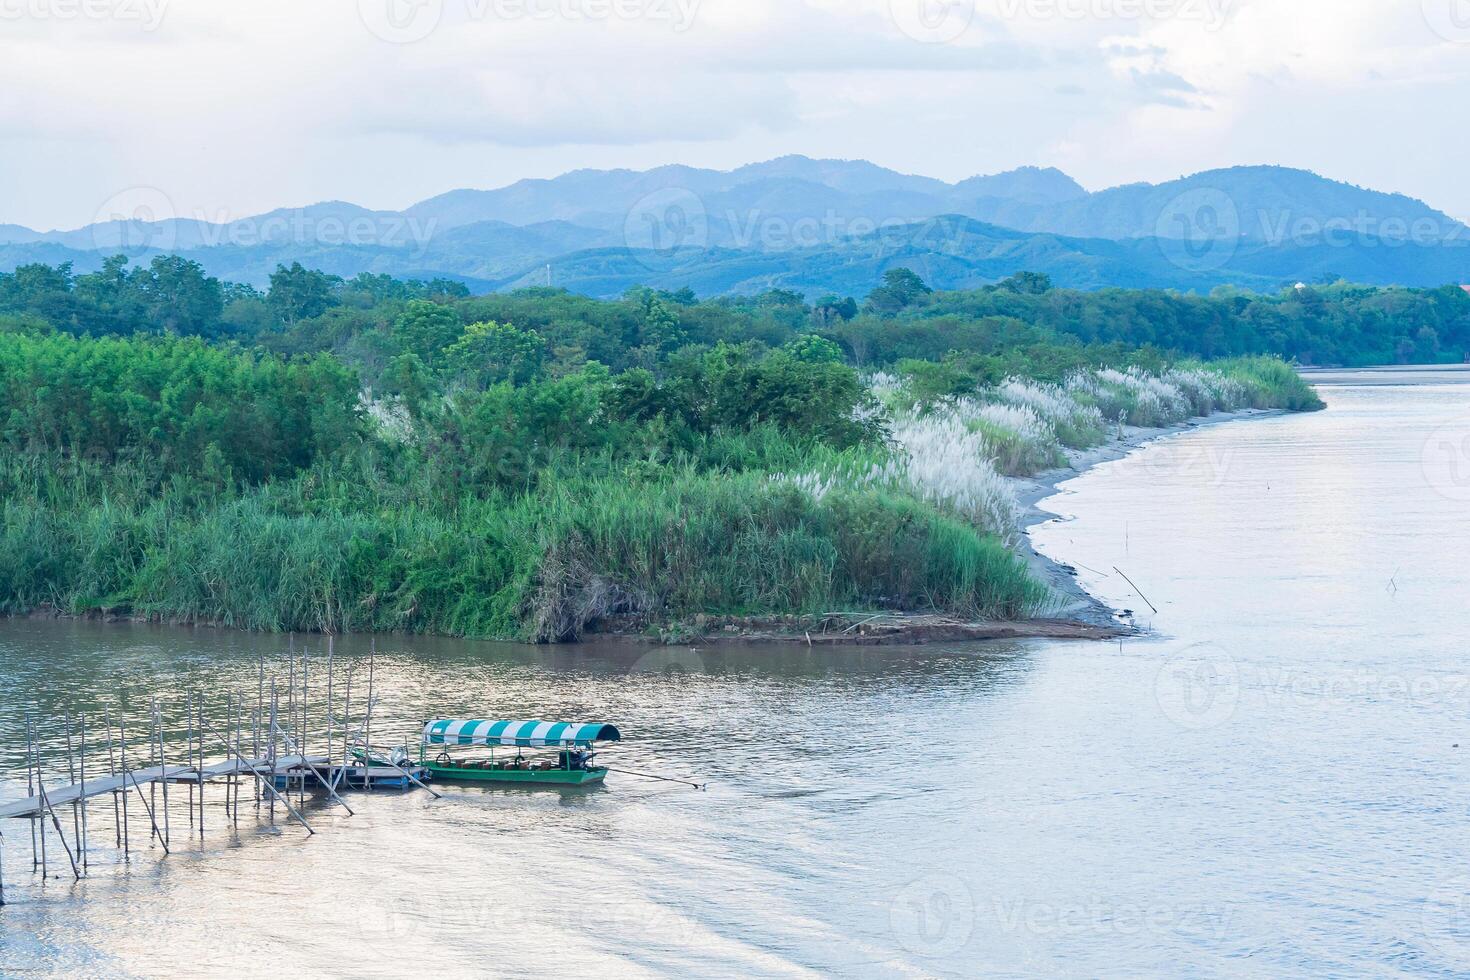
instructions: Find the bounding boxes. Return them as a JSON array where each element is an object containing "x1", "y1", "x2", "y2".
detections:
[{"x1": 0, "y1": 455, "x2": 1045, "y2": 641}]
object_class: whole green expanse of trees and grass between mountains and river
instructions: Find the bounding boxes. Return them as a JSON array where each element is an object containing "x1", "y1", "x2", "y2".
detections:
[{"x1": 0, "y1": 257, "x2": 1334, "y2": 641}]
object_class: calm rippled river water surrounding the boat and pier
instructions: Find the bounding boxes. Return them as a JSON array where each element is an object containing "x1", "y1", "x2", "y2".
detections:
[{"x1": 0, "y1": 373, "x2": 1470, "y2": 977}]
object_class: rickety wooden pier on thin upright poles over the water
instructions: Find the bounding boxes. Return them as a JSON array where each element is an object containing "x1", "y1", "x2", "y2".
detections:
[{"x1": 0, "y1": 639, "x2": 426, "y2": 907}]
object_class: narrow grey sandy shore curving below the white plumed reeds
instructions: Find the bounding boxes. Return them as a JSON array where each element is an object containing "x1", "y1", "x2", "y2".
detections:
[{"x1": 1010, "y1": 408, "x2": 1285, "y2": 629}]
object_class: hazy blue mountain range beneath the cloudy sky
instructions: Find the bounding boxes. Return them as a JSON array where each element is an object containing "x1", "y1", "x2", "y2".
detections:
[{"x1": 0, "y1": 156, "x2": 1470, "y2": 297}]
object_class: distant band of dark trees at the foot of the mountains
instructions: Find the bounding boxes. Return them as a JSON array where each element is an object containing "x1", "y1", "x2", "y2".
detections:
[{"x1": 0, "y1": 256, "x2": 1470, "y2": 373}]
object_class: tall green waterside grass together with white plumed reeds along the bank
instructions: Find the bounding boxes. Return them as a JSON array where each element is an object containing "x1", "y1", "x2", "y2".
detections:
[{"x1": 0, "y1": 359, "x2": 1320, "y2": 641}]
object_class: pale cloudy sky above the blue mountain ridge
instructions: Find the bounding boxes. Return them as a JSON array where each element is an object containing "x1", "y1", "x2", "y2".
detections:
[{"x1": 0, "y1": 0, "x2": 1470, "y2": 229}]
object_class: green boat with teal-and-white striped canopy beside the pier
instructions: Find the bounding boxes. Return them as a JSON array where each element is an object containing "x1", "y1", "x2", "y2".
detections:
[{"x1": 419, "y1": 718, "x2": 623, "y2": 786}]
